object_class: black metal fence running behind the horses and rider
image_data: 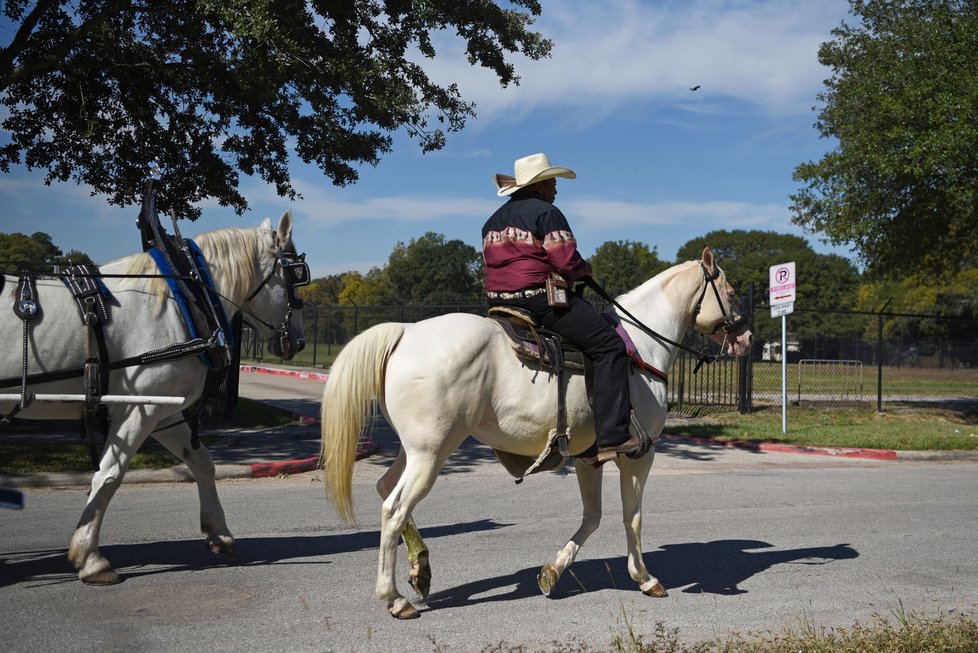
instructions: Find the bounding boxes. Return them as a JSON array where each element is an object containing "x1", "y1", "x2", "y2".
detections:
[{"x1": 242, "y1": 300, "x2": 978, "y2": 412}]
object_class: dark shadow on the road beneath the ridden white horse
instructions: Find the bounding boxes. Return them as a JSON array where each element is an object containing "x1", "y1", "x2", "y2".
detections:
[{"x1": 426, "y1": 540, "x2": 859, "y2": 610}]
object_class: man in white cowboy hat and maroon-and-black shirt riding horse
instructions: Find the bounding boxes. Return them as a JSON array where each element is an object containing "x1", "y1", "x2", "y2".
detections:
[{"x1": 482, "y1": 154, "x2": 641, "y2": 466}]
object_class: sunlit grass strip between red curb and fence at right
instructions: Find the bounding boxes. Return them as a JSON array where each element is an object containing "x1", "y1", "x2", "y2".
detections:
[{"x1": 664, "y1": 406, "x2": 978, "y2": 451}]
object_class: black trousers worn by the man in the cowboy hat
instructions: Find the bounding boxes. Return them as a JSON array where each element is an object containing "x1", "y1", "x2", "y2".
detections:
[{"x1": 489, "y1": 293, "x2": 631, "y2": 447}]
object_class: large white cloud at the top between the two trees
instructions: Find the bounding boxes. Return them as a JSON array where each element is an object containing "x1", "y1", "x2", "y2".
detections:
[{"x1": 423, "y1": 0, "x2": 848, "y2": 126}]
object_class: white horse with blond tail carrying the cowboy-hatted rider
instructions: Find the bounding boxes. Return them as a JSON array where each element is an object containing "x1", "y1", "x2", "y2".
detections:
[{"x1": 322, "y1": 248, "x2": 751, "y2": 619}]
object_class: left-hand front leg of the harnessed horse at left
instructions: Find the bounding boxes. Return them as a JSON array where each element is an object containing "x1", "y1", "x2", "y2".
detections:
[{"x1": 68, "y1": 407, "x2": 156, "y2": 585}]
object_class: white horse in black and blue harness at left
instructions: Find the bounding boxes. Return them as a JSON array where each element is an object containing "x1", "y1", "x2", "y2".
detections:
[{"x1": 0, "y1": 212, "x2": 304, "y2": 585}]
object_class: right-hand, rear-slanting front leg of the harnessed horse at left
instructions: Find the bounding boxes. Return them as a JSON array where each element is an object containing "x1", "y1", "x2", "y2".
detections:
[{"x1": 151, "y1": 415, "x2": 234, "y2": 557}]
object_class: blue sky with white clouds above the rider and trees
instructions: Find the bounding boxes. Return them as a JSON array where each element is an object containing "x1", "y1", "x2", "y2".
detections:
[{"x1": 0, "y1": 0, "x2": 852, "y2": 277}]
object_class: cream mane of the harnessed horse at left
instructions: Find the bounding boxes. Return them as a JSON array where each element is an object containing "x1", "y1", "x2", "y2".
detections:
[{"x1": 120, "y1": 227, "x2": 262, "y2": 309}]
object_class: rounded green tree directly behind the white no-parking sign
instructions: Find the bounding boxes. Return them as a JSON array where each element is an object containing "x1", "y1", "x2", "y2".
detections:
[{"x1": 677, "y1": 230, "x2": 859, "y2": 340}]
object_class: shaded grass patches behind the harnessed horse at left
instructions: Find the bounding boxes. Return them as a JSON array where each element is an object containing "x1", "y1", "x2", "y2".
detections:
[{"x1": 0, "y1": 399, "x2": 297, "y2": 474}]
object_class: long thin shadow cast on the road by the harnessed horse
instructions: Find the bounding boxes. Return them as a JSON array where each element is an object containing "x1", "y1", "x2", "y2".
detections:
[{"x1": 0, "y1": 519, "x2": 504, "y2": 587}]
